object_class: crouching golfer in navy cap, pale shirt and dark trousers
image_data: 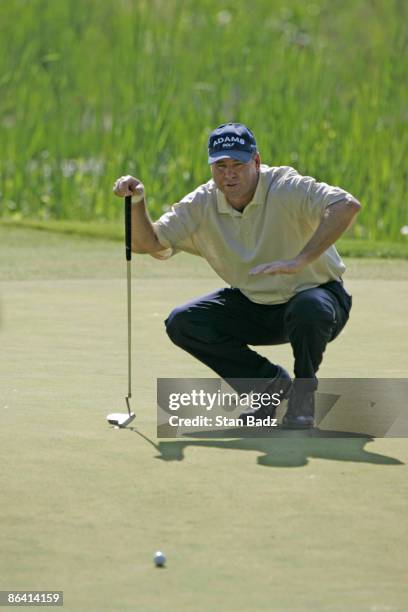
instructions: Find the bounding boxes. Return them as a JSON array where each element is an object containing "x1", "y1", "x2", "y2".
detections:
[{"x1": 113, "y1": 123, "x2": 361, "y2": 429}]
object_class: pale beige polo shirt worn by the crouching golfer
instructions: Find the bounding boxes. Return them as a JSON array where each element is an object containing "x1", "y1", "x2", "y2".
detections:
[{"x1": 154, "y1": 165, "x2": 352, "y2": 304}]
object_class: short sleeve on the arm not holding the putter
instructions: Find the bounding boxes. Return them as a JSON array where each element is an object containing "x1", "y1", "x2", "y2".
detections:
[{"x1": 281, "y1": 167, "x2": 353, "y2": 223}]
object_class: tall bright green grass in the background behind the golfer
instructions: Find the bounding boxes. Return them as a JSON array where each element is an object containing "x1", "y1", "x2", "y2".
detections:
[{"x1": 0, "y1": 0, "x2": 408, "y2": 240}]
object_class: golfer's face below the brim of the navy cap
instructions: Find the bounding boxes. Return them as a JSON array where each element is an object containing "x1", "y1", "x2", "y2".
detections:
[{"x1": 211, "y1": 153, "x2": 261, "y2": 206}]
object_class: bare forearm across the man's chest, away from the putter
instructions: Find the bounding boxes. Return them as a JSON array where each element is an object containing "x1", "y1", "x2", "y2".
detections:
[{"x1": 296, "y1": 200, "x2": 361, "y2": 265}]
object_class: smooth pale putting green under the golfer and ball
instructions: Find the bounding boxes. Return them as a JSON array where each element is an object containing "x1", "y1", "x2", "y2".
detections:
[{"x1": 0, "y1": 227, "x2": 408, "y2": 612}]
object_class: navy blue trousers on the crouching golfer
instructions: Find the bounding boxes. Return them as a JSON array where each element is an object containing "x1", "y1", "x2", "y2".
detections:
[{"x1": 165, "y1": 281, "x2": 351, "y2": 390}]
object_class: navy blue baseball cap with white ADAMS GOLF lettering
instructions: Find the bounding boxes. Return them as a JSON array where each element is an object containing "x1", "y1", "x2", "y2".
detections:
[{"x1": 208, "y1": 123, "x2": 258, "y2": 164}]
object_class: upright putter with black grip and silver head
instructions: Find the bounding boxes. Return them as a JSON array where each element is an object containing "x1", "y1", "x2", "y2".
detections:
[{"x1": 106, "y1": 196, "x2": 135, "y2": 427}]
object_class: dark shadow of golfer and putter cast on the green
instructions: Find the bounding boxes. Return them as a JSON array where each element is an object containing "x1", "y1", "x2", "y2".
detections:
[{"x1": 129, "y1": 427, "x2": 404, "y2": 467}]
